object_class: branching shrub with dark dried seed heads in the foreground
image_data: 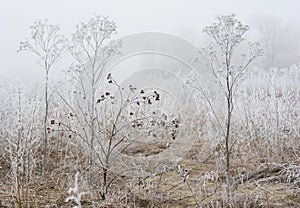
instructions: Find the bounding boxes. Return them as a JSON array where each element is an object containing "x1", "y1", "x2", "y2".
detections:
[{"x1": 53, "y1": 74, "x2": 179, "y2": 199}]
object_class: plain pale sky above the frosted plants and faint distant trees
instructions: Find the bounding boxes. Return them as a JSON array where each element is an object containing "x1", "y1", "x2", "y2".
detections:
[{"x1": 0, "y1": 0, "x2": 300, "y2": 87}]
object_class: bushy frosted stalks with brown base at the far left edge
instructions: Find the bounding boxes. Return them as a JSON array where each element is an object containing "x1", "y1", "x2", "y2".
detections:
[{"x1": 0, "y1": 84, "x2": 41, "y2": 206}]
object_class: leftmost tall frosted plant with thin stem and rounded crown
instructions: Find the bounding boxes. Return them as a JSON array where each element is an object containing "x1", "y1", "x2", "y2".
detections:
[{"x1": 18, "y1": 20, "x2": 67, "y2": 173}]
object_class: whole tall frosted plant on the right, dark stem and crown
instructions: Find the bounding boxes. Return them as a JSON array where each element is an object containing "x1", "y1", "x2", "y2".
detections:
[{"x1": 190, "y1": 14, "x2": 262, "y2": 200}]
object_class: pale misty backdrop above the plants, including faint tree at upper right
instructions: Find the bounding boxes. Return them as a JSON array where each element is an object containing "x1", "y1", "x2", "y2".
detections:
[{"x1": 0, "y1": 0, "x2": 300, "y2": 86}]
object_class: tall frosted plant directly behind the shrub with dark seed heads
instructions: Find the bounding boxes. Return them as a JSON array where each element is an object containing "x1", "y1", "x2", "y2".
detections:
[{"x1": 68, "y1": 15, "x2": 120, "y2": 172}]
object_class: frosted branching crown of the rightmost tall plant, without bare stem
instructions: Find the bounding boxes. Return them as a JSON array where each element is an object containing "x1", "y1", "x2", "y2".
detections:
[{"x1": 195, "y1": 14, "x2": 263, "y2": 96}]
